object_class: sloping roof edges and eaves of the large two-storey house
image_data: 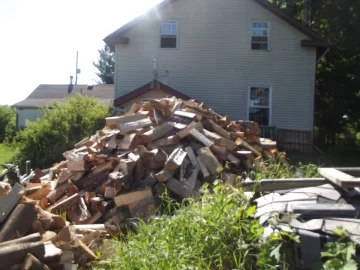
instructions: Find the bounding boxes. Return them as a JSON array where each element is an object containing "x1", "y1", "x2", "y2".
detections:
[{"x1": 104, "y1": 0, "x2": 328, "y2": 50}]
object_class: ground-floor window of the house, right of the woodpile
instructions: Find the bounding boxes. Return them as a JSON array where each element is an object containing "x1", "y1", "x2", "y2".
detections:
[{"x1": 249, "y1": 87, "x2": 271, "y2": 126}]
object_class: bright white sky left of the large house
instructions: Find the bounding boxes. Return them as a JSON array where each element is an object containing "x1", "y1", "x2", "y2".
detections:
[{"x1": 0, "y1": 0, "x2": 161, "y2": 105}]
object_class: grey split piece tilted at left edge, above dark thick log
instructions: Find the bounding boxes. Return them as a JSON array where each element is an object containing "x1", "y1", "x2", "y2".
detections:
[{"x1": 0, "y1": 183, "x2": 25, "y2": 224}]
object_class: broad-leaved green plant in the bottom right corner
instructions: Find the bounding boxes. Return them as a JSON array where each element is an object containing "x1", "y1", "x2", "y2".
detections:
[{"x1": 316, "y1": 227, "x2": 358, "y2": 270}]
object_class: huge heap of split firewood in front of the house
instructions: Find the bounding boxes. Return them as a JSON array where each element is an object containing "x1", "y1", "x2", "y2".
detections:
[{"x1": 0, "y1": 97, "x2": 284, "y2": 269}]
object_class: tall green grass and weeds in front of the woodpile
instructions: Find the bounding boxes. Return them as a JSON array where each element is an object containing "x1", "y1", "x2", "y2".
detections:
[{"x1": 97, "y1": 185, "x2": 291, "y2": 269}]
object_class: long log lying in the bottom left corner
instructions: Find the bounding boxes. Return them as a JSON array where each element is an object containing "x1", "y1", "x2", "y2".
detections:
[{"x1": 0, "y1": 241, "x2": 45, "y2": 269}]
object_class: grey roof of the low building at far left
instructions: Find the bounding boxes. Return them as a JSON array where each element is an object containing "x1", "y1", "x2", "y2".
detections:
[{"x1": 12, "y1": 84, "x2": 114, "y2": 108}]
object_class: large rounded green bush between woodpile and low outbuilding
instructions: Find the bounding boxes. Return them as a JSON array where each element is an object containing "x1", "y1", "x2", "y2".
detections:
[{"x1": 14, "y1": 95, "x2": 111, "y2": 170}]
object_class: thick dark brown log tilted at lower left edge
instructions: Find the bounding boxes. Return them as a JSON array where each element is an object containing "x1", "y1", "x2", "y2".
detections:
[{"x1": 0, "y1": 204, "x2": 37, "y2": 242}]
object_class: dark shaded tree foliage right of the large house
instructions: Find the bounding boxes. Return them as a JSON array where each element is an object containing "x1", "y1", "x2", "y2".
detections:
[{"x1": 280, "y1": 0, "x2": 360, "y2": 144}]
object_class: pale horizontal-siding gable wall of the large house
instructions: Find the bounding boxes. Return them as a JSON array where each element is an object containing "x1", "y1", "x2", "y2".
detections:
[{"x1": 115, "y1": 0, "x2": 316, "y2": 130}]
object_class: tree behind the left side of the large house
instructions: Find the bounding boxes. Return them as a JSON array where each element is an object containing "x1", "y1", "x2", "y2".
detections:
[{"x1": 93, "y1": 45, "x2": 115, "y2": 84}]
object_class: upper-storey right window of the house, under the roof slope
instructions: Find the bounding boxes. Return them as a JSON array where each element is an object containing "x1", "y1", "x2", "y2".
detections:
[{"x1": 251, "y1": 22, "x2": 270, "y2": 51}]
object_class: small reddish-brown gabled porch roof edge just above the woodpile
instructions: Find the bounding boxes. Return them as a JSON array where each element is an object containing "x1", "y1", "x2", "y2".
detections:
[{"x1": 114, "y1": 81, "x2": 191, "y2": 107}]
